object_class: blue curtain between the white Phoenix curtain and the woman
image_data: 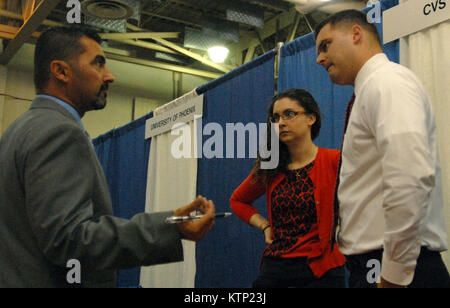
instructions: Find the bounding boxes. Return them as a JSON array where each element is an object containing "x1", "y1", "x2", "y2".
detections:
[{"x1": 195, "y1": 52, "x2": 275, "y2": 288}]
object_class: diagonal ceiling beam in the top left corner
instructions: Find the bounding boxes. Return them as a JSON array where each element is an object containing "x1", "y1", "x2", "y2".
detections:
[{"x1": 0, "y1": 0, "x2": 59, "y2": 65}]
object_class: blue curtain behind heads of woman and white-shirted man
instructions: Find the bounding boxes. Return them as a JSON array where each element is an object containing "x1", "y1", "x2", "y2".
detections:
[{"x1": 278, "y1": 0, "x2": 399, "y2": 149}]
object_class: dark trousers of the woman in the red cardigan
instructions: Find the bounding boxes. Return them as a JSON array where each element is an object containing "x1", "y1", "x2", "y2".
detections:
[{"x1": 253, "y1": 257, "x2": 346, "y2": 288}]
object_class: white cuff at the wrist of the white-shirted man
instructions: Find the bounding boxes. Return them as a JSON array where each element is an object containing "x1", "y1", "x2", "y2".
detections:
[{"x1": 381, "y1": 254, "x2": 416, "y2": 286}]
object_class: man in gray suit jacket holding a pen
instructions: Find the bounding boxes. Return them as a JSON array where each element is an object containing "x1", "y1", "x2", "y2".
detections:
[{"x1": 0, "y1": 28, "x2": 214, "y2": 287}]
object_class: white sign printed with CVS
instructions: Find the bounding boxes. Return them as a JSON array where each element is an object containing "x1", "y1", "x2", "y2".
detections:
[{"x1": 383, "y1": 0, "x2": 450, "y2": 44}]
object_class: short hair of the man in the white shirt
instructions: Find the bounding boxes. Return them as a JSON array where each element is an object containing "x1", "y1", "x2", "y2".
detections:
[{"x1": 314, "y1": 10, "x2": 381, "y2": 45}]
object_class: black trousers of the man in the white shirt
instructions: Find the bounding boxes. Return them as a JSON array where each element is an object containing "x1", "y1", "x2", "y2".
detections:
[{"x1": 346, "y1": 247, "x2": 450, "y2": 288}]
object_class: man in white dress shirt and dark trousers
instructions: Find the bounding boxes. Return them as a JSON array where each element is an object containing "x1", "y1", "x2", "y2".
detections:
[{"x1": 315, "y1": 10, "x2": 450, "y2": 287}]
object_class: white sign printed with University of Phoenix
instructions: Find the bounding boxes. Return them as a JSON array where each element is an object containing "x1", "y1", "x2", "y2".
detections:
[{"x1": 145, "y1": 95, "x2": 203, "y2": 139}]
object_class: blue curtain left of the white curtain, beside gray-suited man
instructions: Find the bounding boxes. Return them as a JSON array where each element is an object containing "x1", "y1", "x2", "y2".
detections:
[{"x1": 93, "y1": 113, "x2": 153, "y2": 287}]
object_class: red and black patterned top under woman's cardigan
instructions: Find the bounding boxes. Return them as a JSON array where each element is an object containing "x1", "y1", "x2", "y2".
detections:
[{"x1": 264, "y1": 162, "x2": 320, "y2": 258}]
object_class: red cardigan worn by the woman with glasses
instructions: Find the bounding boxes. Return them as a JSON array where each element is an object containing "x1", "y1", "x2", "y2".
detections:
[{"x1": 230, "y1": 147, "x2": 345, "y2": 277}]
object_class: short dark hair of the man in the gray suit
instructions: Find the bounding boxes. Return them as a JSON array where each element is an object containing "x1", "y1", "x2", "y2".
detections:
[{"x1": 34, "y1": 27, "x2": 101, "y2": 93}]
